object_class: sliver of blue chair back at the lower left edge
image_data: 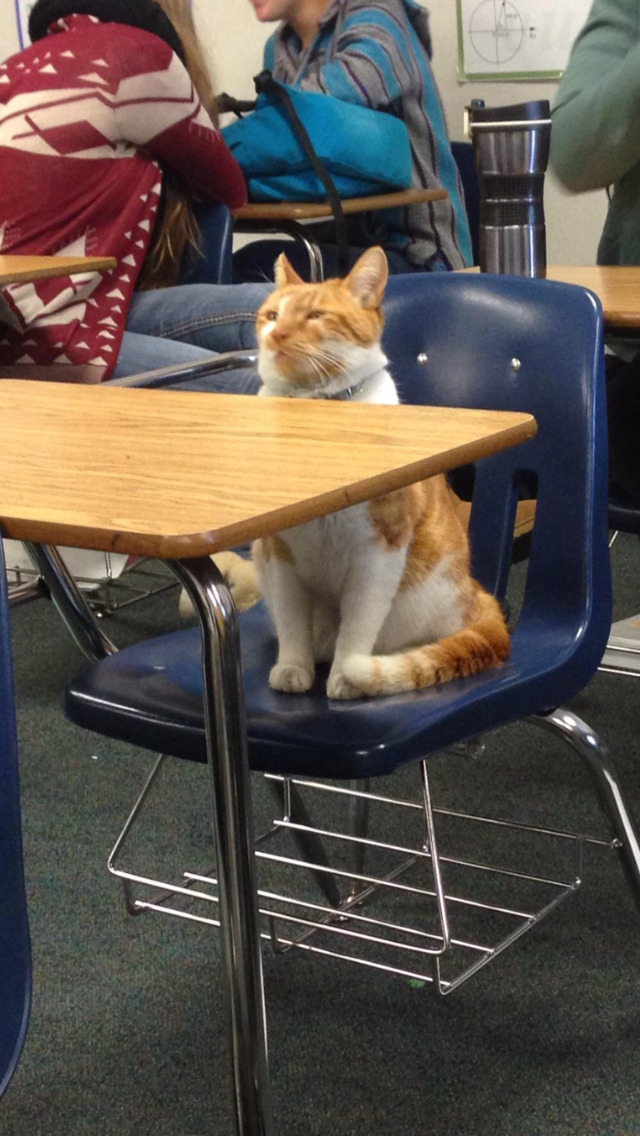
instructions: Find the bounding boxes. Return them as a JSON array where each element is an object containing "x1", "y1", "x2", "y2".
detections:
[{"x1": 0, "y1": 541, "x2": 31, "y2": 1096}]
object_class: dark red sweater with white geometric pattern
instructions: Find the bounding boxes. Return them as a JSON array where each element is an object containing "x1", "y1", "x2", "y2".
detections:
[{"x1": 0, "y1": 15, "x2": 246, "y2": 382}]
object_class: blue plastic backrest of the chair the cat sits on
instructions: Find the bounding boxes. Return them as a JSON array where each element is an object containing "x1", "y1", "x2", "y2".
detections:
[{"x1": 383, "y1": 273, "x2": 610, "y2": 686}]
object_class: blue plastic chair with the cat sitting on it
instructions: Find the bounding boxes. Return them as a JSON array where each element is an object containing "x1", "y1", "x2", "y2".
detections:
[{"x1": 65, "y1": 274, "x2": 640, "y2": 896}]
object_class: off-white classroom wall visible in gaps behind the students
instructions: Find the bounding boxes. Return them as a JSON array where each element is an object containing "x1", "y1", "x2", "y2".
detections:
[{"x1": 0, "y1": 0, "x2": 606, "y2": 265}]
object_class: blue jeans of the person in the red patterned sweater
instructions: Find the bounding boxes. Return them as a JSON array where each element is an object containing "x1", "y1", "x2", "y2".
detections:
[{"x1": 114, "y1": 284, "x2": 273, "y2": 394}]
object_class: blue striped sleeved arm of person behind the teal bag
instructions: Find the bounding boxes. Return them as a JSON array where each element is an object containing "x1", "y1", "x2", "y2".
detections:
[{"x1": 293, "y1": 2, "x2": 411, "y2": 108}]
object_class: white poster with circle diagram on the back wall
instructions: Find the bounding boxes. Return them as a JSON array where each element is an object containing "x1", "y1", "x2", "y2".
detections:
[{"x1": 457, "y1": 0, "x2": 592, "y2": 80}]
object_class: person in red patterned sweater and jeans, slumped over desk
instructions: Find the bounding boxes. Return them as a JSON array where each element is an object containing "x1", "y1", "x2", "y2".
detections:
[{"x1": 0, "y1": 0, "x2": 265, "y2": 390}]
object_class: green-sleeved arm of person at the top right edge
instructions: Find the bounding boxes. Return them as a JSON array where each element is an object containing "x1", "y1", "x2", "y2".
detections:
[{"x1": 550, "y1": 0, "x2": 640, "y2": 192}]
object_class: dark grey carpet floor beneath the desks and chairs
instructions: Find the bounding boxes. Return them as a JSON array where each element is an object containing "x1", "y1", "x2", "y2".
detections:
[{"x1": 0, "y1": 537, "x2": 640, "y2": 1136}]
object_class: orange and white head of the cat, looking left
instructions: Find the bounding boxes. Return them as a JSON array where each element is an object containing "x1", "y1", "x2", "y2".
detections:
[{"x1": 256, "y1": 248, "x2": 389, "y2": 398}]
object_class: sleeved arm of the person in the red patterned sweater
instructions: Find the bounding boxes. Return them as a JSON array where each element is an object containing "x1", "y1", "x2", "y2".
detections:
[{"x1": 115, "y1": 36, "x2": 247, "y2": 209}]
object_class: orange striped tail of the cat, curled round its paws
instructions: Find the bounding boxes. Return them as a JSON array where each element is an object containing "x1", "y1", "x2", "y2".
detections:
[{"x1": 342, "y1": 591, "x2": 509, "y2": 698}]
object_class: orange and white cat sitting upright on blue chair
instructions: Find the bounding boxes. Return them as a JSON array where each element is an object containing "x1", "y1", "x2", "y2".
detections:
[{"x1": 252, "y1": 249, "x2": 509, "y2": 699}]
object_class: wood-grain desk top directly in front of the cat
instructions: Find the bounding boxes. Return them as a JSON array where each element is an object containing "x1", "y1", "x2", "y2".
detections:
[{"x1": 0, "y1": 379, "x2": 535, "y2": 559}]
